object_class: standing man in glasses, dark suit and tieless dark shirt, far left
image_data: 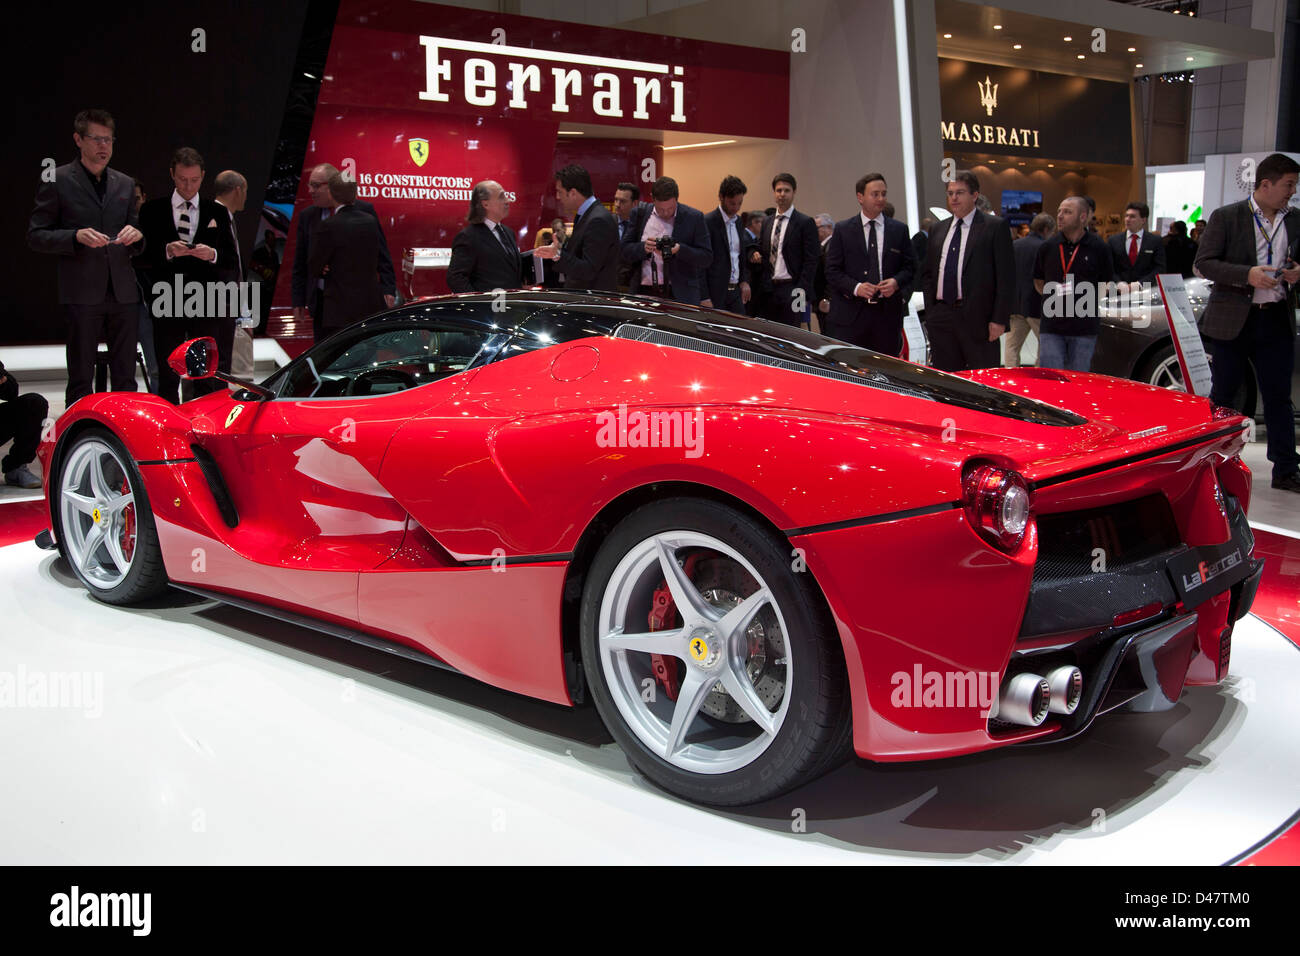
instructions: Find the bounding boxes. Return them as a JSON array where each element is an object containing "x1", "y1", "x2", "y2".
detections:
[{"x1": 27, "y1": 109, "x2": 144, "y2": 406}]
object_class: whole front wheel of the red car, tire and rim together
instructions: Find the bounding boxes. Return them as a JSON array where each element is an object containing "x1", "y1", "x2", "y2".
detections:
[{"x1": 51, "y1": 428, "x2": 168, "y2": 605}]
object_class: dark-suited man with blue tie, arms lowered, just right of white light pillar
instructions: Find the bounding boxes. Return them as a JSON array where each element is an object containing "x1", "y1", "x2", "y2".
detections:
[{"x1": 922, "y1": 169, "x2": 1015, "y2": 372}]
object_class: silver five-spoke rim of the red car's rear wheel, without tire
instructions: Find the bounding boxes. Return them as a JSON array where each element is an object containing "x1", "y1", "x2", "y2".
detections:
[{"x1": 597, "y1": 531, "x2": 793, "y2": 774}]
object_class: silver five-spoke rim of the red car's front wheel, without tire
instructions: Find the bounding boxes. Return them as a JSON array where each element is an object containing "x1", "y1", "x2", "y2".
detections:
[{"x1": 59, "y1": 440, "x2": 137, "y2": 591}]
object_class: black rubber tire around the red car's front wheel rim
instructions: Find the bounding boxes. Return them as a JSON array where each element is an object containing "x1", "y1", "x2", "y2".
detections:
[{"x1": 49, "y1": 428, "x2": 168, "y2": 605}]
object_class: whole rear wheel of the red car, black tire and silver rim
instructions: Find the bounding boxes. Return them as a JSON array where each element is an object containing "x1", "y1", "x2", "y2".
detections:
[{"x1": 581, "y1": 498, "x2": 852, "y2": 806}]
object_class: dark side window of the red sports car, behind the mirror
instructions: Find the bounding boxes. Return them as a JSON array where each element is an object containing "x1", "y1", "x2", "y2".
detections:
[{"x1": 280, "y1": 325, "x2": 490, "y2": 398}]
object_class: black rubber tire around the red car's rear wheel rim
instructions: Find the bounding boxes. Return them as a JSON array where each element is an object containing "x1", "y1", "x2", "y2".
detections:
[{"x1": 581, "y1": 498, "x2": 853, "y2": 806}]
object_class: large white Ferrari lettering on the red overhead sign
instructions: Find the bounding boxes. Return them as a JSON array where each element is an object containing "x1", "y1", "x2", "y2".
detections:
[{"x1": 420, "y1": 36, "x2": 686, "y2": 127}]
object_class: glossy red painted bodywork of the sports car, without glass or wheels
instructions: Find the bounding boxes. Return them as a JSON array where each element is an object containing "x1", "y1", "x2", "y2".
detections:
[{"x1": 40, "y1": 314, "x2": 1248, "y2": 760}]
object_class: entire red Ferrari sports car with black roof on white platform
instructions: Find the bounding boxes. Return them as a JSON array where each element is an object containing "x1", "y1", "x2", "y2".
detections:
[{"x1": 40, "y1": 291, "x2": 1262, "y2": 805}]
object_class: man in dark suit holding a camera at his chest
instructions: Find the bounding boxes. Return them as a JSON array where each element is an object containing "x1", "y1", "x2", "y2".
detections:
[{"x1": 623, "y1": 176, "x2": 714, "y2": 306}]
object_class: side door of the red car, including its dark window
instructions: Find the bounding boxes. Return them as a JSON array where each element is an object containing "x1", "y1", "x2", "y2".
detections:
[{"x1": 180, "y1": 310, "x2": 506, "y2": 622}]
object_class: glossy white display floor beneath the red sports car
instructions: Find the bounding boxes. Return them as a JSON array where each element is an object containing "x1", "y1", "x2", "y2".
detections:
[{"x1": 0, "y1": 544, "x2": 1300, "y2": 865}]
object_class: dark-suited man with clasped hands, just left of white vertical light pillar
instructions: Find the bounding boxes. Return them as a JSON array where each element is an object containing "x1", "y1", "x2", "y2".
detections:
[{"x1": 826, "y1": 173, "x2": 917, "y2": 355}]
